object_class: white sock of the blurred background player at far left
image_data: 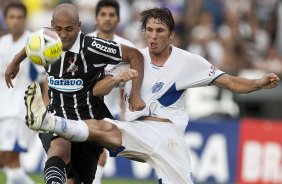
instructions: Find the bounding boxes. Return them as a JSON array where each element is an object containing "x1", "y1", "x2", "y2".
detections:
[{"x1": 5, "y1": 167, "x2": 34, "y2": 184}]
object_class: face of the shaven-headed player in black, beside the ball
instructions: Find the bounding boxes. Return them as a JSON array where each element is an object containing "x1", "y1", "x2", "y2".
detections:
[{"x1": 51, "y1": 17, "x2": 81, "y2": 51}]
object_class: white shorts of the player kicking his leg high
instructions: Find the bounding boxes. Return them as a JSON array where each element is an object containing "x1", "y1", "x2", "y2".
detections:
[{"x1": 104, "y1": 118, "x2": 194, "y2": 184}]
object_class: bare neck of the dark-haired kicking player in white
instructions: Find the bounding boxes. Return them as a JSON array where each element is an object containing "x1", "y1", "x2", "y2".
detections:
[{"x1": 150, "y1": 45, "x2": 172, "y2": 66}]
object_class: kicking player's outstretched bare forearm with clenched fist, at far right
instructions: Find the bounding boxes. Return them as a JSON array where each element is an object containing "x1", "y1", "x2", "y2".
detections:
[{"x1": 214, "y1": 73, "x2": 280, "y2": 93}]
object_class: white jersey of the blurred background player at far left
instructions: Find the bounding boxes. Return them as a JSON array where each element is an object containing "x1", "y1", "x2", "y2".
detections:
[{"x1": 0, "y1": 31, "x2": 31, "y2": 120}]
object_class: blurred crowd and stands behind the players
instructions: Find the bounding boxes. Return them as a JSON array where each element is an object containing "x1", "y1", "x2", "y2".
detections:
[{"x1": 0, "y1": 0, "x2": 282, "y2": 119}]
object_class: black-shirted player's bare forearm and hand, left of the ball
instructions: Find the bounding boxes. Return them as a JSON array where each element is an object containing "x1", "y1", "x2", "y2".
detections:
[{"x1": 5, "y1": 48, "x2": 26, "y2": 88}]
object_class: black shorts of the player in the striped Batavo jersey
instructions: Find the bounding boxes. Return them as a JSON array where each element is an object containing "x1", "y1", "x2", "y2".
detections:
[{"x1": 39, "y1": 133, "x2": 104, "y2": 184}]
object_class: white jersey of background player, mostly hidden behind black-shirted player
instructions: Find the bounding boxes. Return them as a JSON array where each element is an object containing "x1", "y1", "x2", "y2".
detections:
[{"x1": 89, "y1": 31, "x2": 134, "y2": 118}]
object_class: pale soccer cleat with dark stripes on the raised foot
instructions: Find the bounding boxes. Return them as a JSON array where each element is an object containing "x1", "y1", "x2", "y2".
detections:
[{"x1": 24, "y1": 82, "x2": 47, "y2": 131}]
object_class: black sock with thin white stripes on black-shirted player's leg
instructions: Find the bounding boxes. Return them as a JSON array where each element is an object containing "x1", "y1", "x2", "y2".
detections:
[{"x1": 44, "y1": 156, "x2": 66, "y2": 184}]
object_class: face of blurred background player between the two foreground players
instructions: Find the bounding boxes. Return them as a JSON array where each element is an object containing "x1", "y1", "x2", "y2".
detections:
[{"x1": 96, "y1": 6, "x2": 119, "y2": 34}]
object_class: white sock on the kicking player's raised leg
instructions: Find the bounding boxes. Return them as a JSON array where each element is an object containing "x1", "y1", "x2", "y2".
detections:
[{"x1": 49, "y1": 116, "x2": 89, "y2": 142}]
